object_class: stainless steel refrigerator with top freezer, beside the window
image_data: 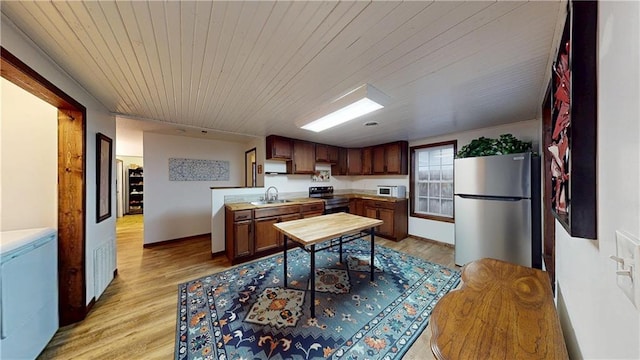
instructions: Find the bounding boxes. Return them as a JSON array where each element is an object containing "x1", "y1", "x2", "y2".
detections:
[{"x1": 454, "y1": 153, "x2": 542, "y2": 268}]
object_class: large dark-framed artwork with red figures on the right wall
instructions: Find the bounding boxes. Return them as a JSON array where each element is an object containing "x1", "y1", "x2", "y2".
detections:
[{"x1": 546, "y1": 1, "x2": 598, "y2": 239}]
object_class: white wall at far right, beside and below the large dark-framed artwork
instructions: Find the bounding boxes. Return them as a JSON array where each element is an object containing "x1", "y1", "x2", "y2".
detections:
[{"x1": 556, "y1": 1, "x2": 640, "y2": 359}]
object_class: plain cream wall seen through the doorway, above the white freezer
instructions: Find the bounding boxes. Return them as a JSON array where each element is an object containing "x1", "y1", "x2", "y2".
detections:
[{"x1": 0, "y1": 78, "x2": 58, "y2": 231}]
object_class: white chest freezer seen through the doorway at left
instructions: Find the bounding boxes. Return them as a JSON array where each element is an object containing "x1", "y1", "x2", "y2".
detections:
[{"x1": 0, "y1": 228, "x2": 58, "y2": 359}]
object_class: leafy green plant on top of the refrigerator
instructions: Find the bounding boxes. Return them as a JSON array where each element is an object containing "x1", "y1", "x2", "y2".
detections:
[{"x1": 456, "y1": 134, "x2": 531, "y2": 159}]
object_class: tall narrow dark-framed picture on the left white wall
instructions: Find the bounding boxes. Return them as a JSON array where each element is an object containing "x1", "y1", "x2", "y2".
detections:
[{"x1": 96, "y1": 133, "x2": 113, "y2": 223}]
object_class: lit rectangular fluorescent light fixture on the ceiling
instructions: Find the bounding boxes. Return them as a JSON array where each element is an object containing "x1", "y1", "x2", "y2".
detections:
[{"x1": 302, "y1": 84, "x2": 389, "y2": 132}]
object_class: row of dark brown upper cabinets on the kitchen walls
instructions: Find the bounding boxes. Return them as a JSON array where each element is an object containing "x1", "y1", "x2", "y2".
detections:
[{"x1": 266, "y1": 135, "x2": 409, "y2": 175}]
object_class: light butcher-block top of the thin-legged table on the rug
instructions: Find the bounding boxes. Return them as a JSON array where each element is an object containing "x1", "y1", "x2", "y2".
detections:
[{"x1": 273, "y1": 212, "x2": 383, "y2": 246}]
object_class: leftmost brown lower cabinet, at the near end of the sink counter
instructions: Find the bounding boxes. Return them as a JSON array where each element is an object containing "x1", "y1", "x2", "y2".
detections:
[{"x1": 225, "y1": 209, "x2": 254, "y2": 262}]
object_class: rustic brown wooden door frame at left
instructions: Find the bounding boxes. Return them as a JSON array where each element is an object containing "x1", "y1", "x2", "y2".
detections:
[{"x1": 0, "y1": 47, "x2": 89, "y2": 326}]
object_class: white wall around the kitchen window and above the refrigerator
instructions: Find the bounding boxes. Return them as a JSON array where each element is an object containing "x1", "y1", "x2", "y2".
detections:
[{"x1": 407, "y1": 120, "x2": 541, "y2": 244}]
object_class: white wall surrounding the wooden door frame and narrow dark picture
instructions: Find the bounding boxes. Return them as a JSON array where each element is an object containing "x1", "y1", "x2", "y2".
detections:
[{"x1": 0, "y1": 15, "x2": 116, "y2": 304}]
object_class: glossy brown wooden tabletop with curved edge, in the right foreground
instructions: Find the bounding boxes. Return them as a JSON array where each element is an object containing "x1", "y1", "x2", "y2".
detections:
[{"x1": 431, "y1": 259, "x2": 569, "y2": 360}]
